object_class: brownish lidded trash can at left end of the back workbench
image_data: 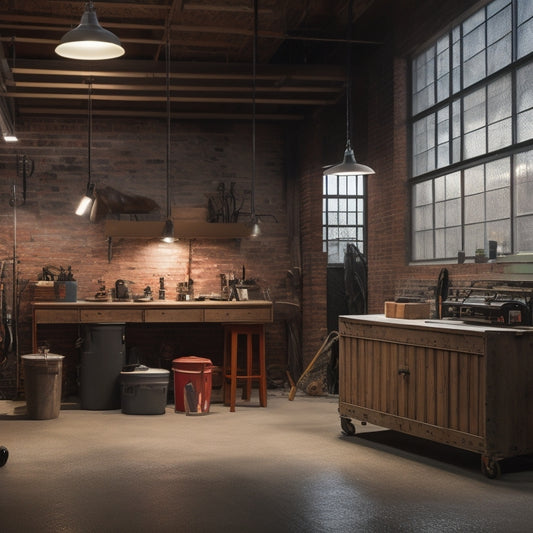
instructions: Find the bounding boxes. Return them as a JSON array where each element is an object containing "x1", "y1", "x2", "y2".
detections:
[{"x1": 22, "y1": 353, "x2": 65, "y2": 420}]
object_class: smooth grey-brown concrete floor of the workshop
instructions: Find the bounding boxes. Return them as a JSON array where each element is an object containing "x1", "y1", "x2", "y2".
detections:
[{"x1": 0, "y1": 391, "x2": 533, "y2": 533}]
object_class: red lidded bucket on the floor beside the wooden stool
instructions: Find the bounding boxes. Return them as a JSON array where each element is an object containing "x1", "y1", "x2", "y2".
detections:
[{"x1": 172, "y1": 355, "x2": 213, "y2": 415}]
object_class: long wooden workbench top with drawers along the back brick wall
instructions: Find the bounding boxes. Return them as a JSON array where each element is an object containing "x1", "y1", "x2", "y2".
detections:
[{"x1": 32, "y1": 300, "x2": 273, "y2": 352}]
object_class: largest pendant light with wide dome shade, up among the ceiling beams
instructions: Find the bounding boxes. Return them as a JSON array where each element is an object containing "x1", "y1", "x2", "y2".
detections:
[{"x1": 55, "y1": 2, "x2": 125, "y2": 60}]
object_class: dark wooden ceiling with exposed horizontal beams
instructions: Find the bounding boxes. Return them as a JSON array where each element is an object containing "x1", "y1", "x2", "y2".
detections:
[{"x1": 0, "y1": 0, "x2": 366, "y2": 120}]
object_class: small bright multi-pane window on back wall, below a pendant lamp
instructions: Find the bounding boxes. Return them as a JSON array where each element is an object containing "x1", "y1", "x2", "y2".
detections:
[{"x1": 322, "y1": 175, "x2": 365, "y2": 264}]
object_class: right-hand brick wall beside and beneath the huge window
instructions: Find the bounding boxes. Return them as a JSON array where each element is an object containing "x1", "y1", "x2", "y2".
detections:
[{"x1": 359, "y1": 0, "x2": 501, "y2": 313}]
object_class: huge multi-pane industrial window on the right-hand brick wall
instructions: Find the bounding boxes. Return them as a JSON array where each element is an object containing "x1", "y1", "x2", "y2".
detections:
[{"x1": 411, "y1": 0, "x2": 533, "y2": 261}]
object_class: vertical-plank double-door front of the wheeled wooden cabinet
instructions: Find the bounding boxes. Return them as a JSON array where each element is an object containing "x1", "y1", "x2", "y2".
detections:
[{"x1": 339, "y1": 337, "x2": 485, "y2": 435}]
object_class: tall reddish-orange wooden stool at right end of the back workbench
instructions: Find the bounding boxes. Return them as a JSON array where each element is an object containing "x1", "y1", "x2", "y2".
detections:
[{"x1": 224, "y1": 324, "x2": 267, "y2": 412}]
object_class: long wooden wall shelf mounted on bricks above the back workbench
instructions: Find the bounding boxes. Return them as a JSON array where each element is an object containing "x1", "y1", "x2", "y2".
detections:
[{"x1": 105, "y1": 219, "x2": 251, "y2": 239}]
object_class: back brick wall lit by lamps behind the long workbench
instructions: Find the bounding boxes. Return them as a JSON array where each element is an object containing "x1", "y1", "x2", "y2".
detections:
[{"x1": 0, "y1": 114, "x2": 291, "y2": 397}]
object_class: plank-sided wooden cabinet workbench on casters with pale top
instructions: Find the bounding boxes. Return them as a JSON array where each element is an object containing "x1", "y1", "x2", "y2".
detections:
[{"x1": 339, "y1": 315, "x2": 533, "y2": 478}]
